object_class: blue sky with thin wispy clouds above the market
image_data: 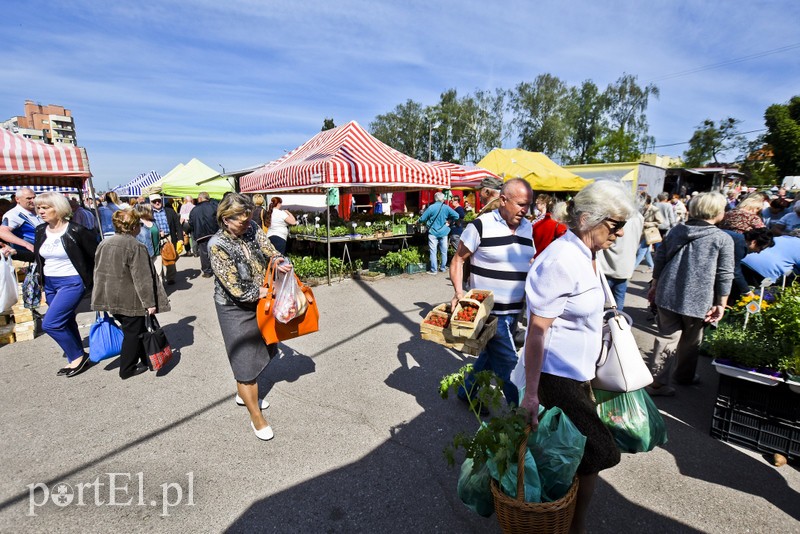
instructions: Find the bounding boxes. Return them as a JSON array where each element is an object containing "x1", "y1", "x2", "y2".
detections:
[{"x1": 0, "y1": 0, "x2": 800, "y2": 189}]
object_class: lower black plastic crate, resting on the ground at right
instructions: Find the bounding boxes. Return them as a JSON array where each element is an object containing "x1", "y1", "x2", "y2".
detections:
[{"x1": 711, "y1": 406, "x2": 800, "y2": 461}]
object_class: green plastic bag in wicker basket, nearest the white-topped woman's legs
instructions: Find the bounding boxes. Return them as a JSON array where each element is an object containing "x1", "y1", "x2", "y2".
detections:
[{"x1": 528, "y1": 407, "x2": 586, "y2": 502}]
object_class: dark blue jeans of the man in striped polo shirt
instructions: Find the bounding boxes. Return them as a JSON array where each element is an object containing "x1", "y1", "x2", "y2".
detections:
[{"x1": 458, "y1": 313, "x2": 519, "y2": 406}]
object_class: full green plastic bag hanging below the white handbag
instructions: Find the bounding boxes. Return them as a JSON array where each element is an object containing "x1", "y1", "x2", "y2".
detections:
[{"x1": 594, "y1": 389, "x2": 667, "y2": 453}]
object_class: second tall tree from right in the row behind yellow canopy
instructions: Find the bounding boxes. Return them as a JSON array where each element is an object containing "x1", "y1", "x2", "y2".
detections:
[{"x1": 566, "y1": 80, "x2": 608, "y2": 165}]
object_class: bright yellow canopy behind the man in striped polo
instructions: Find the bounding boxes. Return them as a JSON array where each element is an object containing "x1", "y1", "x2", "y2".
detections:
[{"x1": 478, "y1": 148, "x2": 594, "y2": 191}]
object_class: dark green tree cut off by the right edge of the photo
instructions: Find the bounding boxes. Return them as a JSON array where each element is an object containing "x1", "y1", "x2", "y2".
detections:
[{"x1": 764, "y1": 95, "x2": 800, "y2": 177}]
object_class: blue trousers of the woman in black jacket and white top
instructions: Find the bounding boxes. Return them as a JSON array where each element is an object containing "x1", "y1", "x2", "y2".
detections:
[{"x1": 42, "y1": 275, "x2": 85, "y2": 362}]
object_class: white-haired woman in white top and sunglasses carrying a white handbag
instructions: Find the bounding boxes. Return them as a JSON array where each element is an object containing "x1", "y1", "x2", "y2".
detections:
[{"x1": 521, "y1": 181, "x2": 636, "y2": 532}]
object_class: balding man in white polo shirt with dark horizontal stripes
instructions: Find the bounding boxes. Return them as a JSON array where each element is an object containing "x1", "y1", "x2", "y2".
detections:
[{"x1": 450, "y1": 178, "x2": 536, "y2": 406}]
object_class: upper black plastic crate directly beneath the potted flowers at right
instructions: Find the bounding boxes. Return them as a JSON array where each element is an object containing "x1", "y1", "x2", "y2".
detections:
[{"x1": 717, "y1": 375, "x2": 800, "y2": 425}]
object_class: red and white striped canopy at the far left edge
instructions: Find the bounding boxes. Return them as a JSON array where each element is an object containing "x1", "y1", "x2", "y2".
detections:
[{"x1": 0, "y1": 128, "x2": 92, "y2": 189}]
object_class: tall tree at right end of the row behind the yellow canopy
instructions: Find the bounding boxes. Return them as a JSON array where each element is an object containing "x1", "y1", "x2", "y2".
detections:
[{"x1": 599, "y1": 74, "x2": 659, "y2": 162}]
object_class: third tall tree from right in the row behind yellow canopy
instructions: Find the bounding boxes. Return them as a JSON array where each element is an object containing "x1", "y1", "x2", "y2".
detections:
[{"x1": 509, "y1": 74, "x2": 570, "y2": 157}]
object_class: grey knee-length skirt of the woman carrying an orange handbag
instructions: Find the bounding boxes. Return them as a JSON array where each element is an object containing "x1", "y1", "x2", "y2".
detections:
[{"x1": 214, "y1": 302, "x2": 270, "y2": 382}]
